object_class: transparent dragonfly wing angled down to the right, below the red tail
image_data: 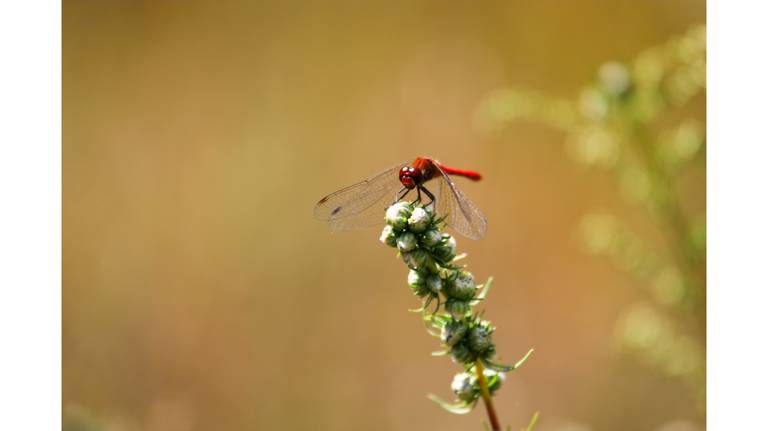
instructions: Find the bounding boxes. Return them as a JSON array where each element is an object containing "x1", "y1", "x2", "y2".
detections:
[{"x1": 435, "y1": 163, "x2": 488, "y2": 239}]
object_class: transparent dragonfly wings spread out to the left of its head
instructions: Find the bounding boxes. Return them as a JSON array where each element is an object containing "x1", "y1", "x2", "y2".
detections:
[{"x1": 315, "y1": 163, "x2": 405, "y2": 230}]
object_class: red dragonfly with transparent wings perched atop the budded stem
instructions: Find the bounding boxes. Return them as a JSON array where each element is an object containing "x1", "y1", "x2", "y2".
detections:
[{"x1": 315, "y1": 157, "x2": 487, "y2": 239}]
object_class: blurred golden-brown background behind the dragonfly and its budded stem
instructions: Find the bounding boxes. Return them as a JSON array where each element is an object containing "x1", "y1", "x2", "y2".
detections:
[{"x1": 62, "y1": 0, "x2": 706, "y2": 431}]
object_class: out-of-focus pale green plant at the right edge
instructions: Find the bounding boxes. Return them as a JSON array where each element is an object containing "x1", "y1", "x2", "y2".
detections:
[{"x1": 476, "y1": 26, "x2": 706, "y2": 406}]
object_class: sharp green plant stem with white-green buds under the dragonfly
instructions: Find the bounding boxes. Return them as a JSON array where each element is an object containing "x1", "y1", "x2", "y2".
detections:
[{"x1": 380, "y1": 202, "x2": 535, "y2": 431}]
